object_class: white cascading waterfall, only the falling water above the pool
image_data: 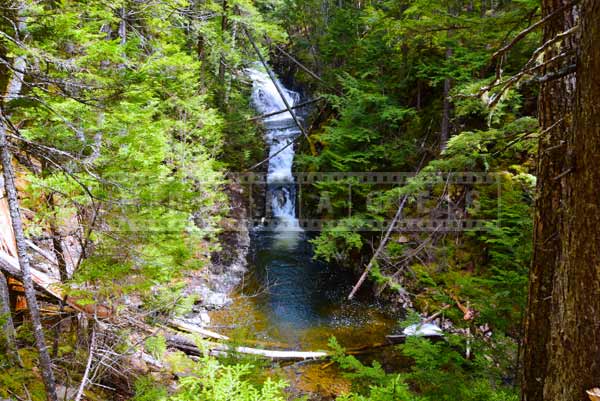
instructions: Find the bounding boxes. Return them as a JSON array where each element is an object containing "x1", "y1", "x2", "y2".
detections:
[{"x1": 247, "y1": 66, "x2": 301, "y2": 230}]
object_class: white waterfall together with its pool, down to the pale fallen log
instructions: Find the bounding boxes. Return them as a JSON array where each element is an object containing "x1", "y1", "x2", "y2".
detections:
[{"x1": 218, "y1": 66, "x2": 395, "y2": 336}]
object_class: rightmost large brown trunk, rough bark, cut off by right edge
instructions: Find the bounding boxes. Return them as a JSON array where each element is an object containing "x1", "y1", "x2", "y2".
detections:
[{"x1": 543, "y1": 0, "x2": 600, "y2": 401}]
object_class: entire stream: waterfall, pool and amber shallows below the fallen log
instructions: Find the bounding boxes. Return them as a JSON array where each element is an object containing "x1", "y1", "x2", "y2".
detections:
[{"x1": 211, "y1": 67, "x2": 396, "y2": 396}]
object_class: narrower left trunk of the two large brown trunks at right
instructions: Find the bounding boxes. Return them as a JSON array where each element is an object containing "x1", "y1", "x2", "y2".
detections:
[{"x1": 522, "y1": 0, "x2": 575, "y2": 401}]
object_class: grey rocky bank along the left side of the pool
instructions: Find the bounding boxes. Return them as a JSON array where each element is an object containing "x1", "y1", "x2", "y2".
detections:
[{"x1": 185, "y1": 183, "x2": 250, "y2": 326}]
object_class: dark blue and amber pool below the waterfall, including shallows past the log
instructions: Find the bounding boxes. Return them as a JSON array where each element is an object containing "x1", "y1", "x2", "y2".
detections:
[{"x1": 211, "y1": 230, "x2": 398, "y2": 397}]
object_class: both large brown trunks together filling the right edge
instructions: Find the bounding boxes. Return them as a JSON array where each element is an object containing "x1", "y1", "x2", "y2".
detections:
[{"x1": 522, "y1": 0, "x2": 600, "y2": 401}]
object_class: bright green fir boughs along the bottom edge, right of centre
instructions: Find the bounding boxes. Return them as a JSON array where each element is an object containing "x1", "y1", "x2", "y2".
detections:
[{"x1": 330, "y1": 336, "x2": 518, "y2": 401}]
